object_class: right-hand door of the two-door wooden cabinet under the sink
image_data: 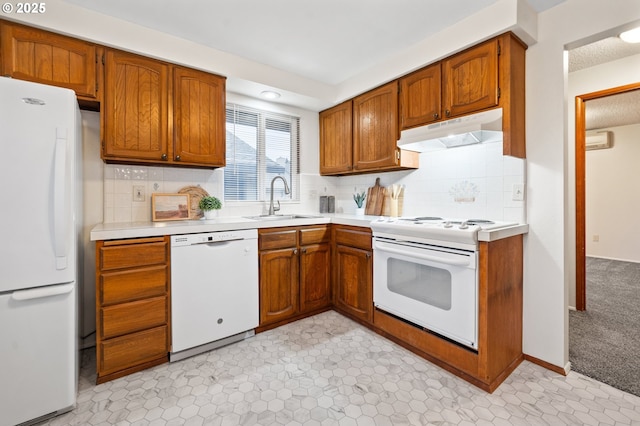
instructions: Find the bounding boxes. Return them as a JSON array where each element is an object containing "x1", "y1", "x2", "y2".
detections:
[{"x1": 300, "y1": 243, "x2": 331, "y2": 312}]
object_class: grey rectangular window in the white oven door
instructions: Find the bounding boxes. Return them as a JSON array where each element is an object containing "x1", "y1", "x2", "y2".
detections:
[{"x1": 387, "y1": 258, "x2": 452, "y2": 311}]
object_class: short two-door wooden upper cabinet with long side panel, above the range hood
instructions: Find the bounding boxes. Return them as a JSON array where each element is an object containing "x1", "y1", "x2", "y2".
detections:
[{"x1": 400, "y1": 33, "x2": 526, "y2": 158}]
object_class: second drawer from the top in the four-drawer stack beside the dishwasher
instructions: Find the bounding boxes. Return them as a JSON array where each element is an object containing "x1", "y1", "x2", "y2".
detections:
[{"x1": 98, "y1": 265, "x2": 168, "y2": 305}]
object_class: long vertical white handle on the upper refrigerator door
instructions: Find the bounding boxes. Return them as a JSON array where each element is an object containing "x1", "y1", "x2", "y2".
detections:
[{"x1": 53, "y1": 127, "x2": 68, "y2": 269}]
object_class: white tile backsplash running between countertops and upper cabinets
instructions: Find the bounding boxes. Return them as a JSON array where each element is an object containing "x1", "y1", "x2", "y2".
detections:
[{"x1": 104, "y1": 142, "x2": 526, "y2": 223}]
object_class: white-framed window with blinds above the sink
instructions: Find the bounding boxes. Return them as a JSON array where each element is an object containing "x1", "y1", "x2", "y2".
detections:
[{"x1": 224, "y1": 104, "x2": 300, "y2": 201}]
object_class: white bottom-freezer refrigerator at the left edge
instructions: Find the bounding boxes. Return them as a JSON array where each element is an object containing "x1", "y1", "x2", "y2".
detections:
[{"x1": 0, "y1": 77, "x2": 82, "y2": 426}]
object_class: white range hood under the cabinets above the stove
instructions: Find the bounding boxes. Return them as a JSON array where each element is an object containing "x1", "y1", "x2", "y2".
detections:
[{"x1": 398, "y1": 108, "x2": 502, "y2": 152}]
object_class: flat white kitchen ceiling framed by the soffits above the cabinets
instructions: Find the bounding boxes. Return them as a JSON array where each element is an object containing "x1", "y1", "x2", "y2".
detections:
[{"x1": 65, "y1": 0, "x2": 565, "y2": 85}]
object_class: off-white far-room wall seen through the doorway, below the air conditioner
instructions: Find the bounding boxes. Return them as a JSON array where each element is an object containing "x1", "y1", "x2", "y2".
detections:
[{"x1": 586, "y1": 124, "x2": 640, "y2": 262}]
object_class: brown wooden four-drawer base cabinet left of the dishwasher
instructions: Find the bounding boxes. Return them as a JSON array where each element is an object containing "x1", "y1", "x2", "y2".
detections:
[{"x1": 96, "y1": 236, "x2": 170, "y2": 383}]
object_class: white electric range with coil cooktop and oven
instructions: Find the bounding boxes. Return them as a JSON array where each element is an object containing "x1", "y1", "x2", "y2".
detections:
[{"x1": 370, "y1": 216, "x2": 517, "y2": 350}]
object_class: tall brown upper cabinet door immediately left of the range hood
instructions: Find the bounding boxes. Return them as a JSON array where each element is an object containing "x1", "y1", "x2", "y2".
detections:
[{"x1": 353, "y1": 81, "x2": 398, "y2": 171}]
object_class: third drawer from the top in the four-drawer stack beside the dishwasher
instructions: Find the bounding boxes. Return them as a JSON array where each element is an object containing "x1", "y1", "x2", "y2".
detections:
[{"x1": 100, "y1": 296, "x2": 168, "y2": 339}]
